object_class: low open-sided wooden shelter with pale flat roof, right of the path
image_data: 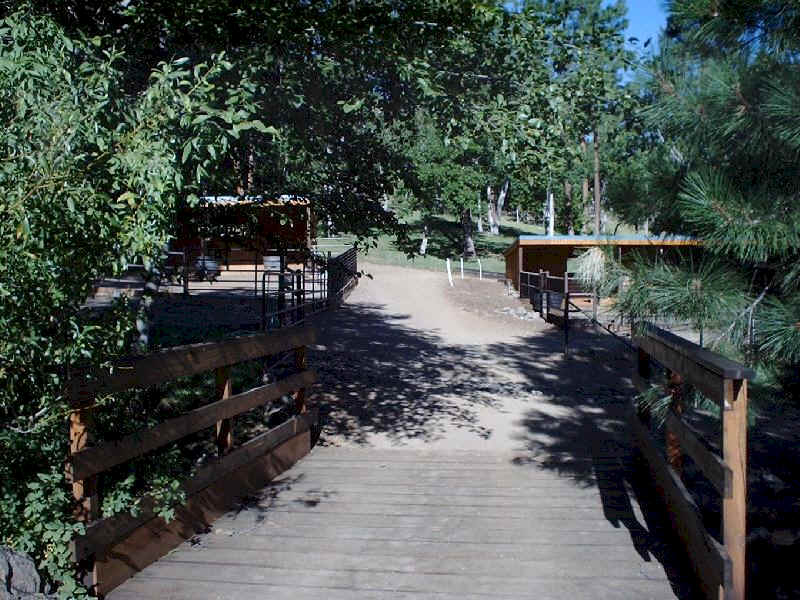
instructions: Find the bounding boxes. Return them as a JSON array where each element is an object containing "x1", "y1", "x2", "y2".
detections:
[{"x1": 503, "y1": 235, "x2": 700, "y2": 289}]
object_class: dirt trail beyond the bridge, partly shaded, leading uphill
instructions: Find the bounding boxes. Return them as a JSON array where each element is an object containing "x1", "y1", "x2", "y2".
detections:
[{"x1": 311, "y1": 265, "x2": 629, "y2": 462}]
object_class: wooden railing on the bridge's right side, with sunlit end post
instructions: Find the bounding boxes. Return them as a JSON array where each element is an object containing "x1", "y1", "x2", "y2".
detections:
[{"x1": 632, "y1": 325, "x2": 754, "y2": 600}]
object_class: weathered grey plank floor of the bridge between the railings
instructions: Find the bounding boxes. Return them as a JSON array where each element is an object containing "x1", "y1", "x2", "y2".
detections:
[{"x1": 109, "y1": 447, "x2": 675, "y2": 600}]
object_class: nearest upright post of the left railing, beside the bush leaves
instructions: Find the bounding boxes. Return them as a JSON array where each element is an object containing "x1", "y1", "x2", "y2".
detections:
[{"x1": 69, "y1": 390, "x2": 100, "y2": 590}]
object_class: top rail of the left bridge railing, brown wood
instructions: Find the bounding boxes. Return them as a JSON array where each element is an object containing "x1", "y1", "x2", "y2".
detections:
[{"x1": 67, "y1": 327, "x2": 316, "y2": 400}]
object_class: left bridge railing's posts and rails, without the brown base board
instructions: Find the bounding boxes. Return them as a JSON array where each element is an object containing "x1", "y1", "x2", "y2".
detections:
[{"x1": 67, "y1": 327, "x2": 317, "y2": 593}]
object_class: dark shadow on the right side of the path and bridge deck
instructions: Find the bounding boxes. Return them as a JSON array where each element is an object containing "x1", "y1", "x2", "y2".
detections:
[{"x1": 490, "y1": 328, "x2": 701, "y2": 600}]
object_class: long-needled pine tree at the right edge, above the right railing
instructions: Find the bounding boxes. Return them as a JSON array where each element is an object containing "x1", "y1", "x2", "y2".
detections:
[{"x1": 622, "y1": 0, "x2": 800, "y2": 397}]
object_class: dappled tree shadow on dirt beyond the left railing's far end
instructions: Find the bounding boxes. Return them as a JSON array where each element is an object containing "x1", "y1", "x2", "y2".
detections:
[{"x1": 309, "y1": 304, "x2": 512, "y2": 444}]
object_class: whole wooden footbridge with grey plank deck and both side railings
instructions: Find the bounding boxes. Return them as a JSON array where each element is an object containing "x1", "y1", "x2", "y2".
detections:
[{"x1": 71, "y1": 316, "x2": 748, "y2": 600}]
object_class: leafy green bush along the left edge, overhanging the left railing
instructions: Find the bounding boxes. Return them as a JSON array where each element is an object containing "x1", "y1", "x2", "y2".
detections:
[{"x1": 0, "y1": 10, "x2": 264, "y2": 597}]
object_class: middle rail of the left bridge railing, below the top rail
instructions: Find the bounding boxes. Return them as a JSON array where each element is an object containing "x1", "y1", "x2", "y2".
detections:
[{"x1": 71, "y1": 370, "x2": 316, "y2": 480}]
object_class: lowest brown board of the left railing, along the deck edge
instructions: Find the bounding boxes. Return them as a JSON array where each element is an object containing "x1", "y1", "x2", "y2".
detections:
[{"x1": 91, "y1": 431, "x2": 311, "y2": 595}]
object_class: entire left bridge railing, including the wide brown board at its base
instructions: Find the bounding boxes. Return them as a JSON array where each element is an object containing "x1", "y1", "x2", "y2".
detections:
[{"x1": 68, "y1": 327, "x2": 317, "y2": 595}]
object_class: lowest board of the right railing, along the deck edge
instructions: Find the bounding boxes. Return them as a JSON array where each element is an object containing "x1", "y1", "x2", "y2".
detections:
[{"x1": 629, "y1": 412, "x2": 731, "y2": 600}]
